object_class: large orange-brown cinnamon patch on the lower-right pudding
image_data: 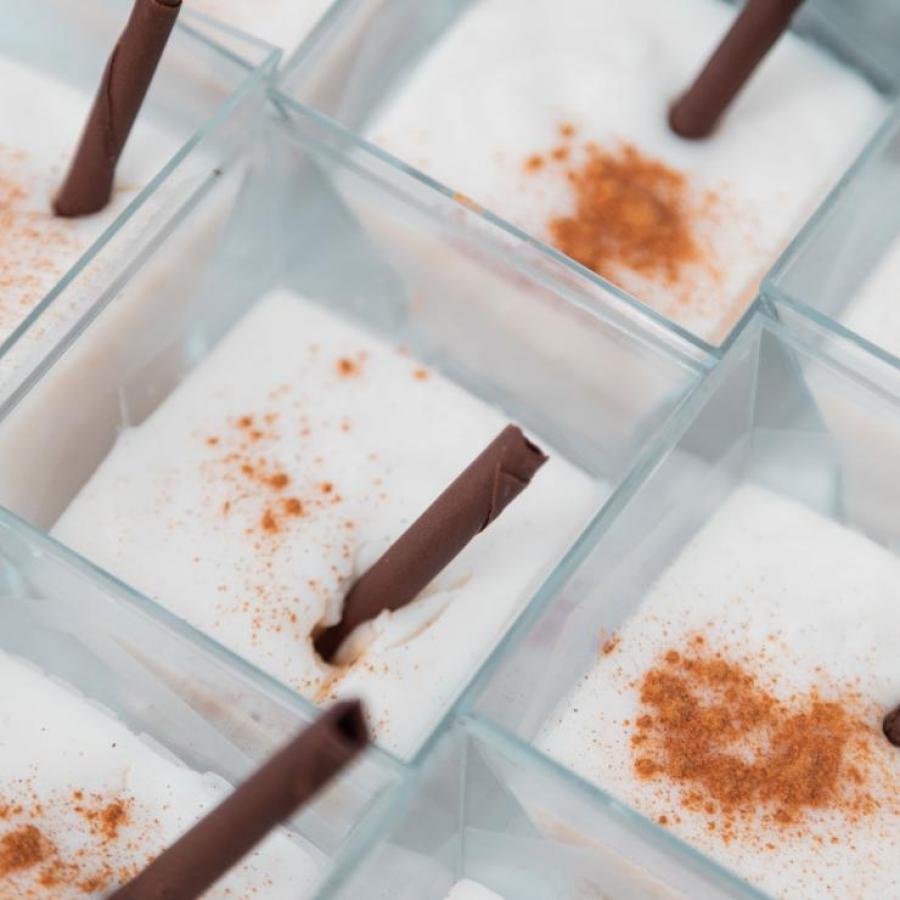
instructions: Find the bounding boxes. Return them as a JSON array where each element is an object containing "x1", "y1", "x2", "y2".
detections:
[{"x1": 631, "y1": 636, "x2": 879, "y2": 841}]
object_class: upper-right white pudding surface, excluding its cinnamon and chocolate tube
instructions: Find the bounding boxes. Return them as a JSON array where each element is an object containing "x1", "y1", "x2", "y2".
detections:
[{"x1": 368, "y1": 0, "x2": 886, "y2": 341}]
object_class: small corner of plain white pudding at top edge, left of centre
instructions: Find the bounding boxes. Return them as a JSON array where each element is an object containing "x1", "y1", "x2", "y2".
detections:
[{"x1": 190, "y1": 0, "x2": 333, "y2": 55}]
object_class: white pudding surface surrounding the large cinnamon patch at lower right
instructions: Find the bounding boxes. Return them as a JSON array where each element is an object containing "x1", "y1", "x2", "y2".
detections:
[{"x1": 537, "y1": 485, "x2": 900, "y2": 898}]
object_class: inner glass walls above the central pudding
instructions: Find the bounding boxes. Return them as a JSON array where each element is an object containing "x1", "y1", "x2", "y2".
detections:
[{"x1": 0, "y1": 98, "x2": 710, "y2": 760}]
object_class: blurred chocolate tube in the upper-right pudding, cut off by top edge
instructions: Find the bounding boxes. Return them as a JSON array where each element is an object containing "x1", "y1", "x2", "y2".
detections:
[{"x1": 669, "y1": 0, "x2": 803, "y2": 139}]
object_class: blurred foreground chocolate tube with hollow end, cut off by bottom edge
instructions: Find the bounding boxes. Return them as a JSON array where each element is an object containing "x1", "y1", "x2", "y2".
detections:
[{"x1": 110, "y1": 700, "x2": 369, "y2": 900}]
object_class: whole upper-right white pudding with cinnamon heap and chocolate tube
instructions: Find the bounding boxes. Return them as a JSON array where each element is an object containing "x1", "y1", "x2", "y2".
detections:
[{"x1": 367, "y1": 0, "x2": 886, "y2": 343}]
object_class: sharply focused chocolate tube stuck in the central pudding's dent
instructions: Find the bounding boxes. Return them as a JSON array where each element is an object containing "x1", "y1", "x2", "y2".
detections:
[{"x1": 315, "y1": 425, "x2": 547, "y2": 660}]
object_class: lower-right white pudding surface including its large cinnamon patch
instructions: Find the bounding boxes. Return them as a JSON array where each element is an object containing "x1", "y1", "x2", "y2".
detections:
[{"x1": 538, "y1": 486, "x2": 900, "y2": 897}]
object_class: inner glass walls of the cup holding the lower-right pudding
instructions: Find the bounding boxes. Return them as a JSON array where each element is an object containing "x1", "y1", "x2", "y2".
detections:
[{"x1": 458, "y1": 315, "x2": 900, "y2": 896}]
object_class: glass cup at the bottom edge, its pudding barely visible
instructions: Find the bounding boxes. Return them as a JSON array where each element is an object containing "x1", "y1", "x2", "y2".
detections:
[{"x1": 322, "y1": 717, "x2": 762, "y2": 900}]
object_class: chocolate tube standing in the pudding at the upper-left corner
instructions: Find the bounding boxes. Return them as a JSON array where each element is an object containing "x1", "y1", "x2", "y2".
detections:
[{"x1": 53, "y1": 0, "x2": 181, "y2": 218}]
